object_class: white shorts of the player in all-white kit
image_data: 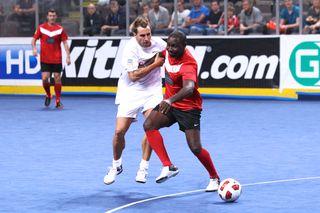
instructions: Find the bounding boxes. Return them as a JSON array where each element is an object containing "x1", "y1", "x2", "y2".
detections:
[{"x1": 117, "y1": 92, "x2": 163, "y2": 119}]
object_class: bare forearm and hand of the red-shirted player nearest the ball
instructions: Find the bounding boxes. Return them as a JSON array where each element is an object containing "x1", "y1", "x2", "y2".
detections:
[{"x1": 159, "y1": 80, "x2": 195, "y2": 114}]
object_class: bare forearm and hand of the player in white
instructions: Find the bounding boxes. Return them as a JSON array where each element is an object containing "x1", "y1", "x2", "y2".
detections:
[{"x1": 128, "y1": 53, "x2": 164, "y2": 81}]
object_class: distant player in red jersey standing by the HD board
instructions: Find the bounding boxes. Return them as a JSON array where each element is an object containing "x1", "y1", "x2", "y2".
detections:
[{"x1": 31, "y1": 9, "x2": 71, "y2": 109}]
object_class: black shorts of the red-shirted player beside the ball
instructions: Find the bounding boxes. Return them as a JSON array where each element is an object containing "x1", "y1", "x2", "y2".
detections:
[{"x1": 153, "y1": 105, "x2": 201, "y2": 132}]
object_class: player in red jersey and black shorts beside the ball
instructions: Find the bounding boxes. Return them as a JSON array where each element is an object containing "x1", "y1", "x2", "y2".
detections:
[{"x1": 143, "y1": 31, "x2": 220, "y2": 192}]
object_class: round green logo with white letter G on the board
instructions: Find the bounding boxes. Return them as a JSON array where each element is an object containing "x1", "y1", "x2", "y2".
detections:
[{"x1": 289, "y1": 42, "x2": 320, "y2": 86}]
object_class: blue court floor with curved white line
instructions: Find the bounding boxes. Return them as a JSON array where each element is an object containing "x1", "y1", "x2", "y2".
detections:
[{"x1": 0, "y1": 96, "x2": 320, "y2": 213}]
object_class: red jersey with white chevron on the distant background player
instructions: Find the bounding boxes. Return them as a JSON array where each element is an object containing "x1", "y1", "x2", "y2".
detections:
[{"x1": 33, "y1": 23, "x2": 68, "y2": 64}]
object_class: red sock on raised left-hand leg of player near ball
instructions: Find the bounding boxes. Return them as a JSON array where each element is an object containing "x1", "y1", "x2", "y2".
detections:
[{"x1": 146, "y1": 130, "x2": 172, "y2": 166}]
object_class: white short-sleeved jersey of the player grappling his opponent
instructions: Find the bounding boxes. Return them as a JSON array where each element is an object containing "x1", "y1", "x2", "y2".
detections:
[{"x1": 116, "y1": 37, "x2": 166, "y2": 104}]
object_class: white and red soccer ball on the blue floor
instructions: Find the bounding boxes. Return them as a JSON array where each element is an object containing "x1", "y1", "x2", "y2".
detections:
[{"x1": 218, "y1": 178, "x2": 241, "y2": 202}]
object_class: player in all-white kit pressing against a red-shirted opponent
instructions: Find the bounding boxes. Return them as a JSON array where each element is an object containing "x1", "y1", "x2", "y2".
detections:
[{"x1": 104, "y1": 16, "x2": 166, "y2": 185}]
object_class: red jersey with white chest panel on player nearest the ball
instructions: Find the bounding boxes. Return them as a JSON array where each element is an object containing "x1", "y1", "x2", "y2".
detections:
[{"x1": 164, "y1": 49, "x2": 202, "y2": 111}]
